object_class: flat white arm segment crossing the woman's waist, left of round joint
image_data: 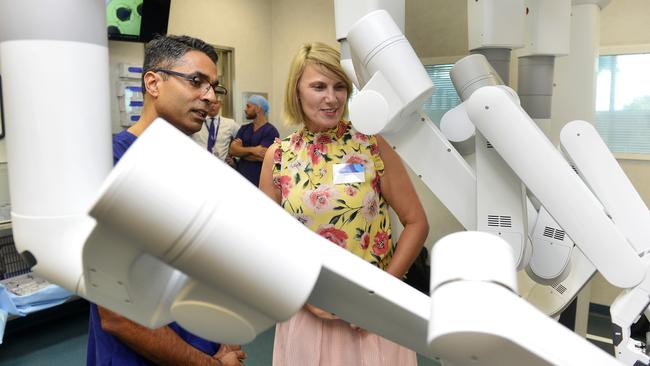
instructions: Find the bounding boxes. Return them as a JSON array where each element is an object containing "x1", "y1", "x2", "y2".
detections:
[{"x1": 305, "y1": 234, "x2": 435, "y2": 358}]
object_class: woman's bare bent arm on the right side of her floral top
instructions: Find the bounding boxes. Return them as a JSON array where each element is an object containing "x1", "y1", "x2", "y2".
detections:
[{"x1": 377, "y1": 136, "x2": 429, "y2": 278}]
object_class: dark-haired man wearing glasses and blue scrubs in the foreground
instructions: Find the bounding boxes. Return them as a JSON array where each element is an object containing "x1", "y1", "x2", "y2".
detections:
[{"x1": 87, "y1": 36, "x2": 246, "y2": 366}]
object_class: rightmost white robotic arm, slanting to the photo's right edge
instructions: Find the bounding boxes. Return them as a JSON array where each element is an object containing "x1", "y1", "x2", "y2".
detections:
[{"x1": 560, "y1": 121, "x2": 650, "y2": 365}]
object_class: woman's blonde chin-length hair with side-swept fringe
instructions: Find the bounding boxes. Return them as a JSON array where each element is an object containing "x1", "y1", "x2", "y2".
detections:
[{"x1": 284, "y1": 42, "x2": 352, "y2": 126}]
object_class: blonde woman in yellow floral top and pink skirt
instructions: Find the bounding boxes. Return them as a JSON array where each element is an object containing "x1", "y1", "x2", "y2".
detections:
[{"x1": 260, "y1": 43, "x2": 429, "y2": 366}]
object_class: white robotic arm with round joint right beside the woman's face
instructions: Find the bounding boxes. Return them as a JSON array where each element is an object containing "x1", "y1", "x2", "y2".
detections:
[{"x1": 344, "y1": 5, "x2": 476, "y2": 230}]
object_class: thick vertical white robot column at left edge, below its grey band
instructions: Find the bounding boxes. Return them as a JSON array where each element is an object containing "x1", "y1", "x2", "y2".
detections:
[{"x1": 0, "y1": 40, "x2": 112, "y2": 292}]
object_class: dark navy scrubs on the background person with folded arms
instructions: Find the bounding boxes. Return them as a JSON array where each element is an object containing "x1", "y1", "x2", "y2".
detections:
[{"x1": 235, "y1": 122, "x2": 280, "y2": 187}]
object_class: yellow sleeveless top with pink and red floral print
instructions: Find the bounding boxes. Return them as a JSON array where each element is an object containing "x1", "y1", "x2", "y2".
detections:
[{"x1": 273, "y1": 121, "x2": 395, "y2": 269}]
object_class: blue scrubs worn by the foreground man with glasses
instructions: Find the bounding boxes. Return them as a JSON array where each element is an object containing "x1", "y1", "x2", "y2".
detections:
[{"x1": 86, "y1": 130, "x2": 219, "y2": 366}]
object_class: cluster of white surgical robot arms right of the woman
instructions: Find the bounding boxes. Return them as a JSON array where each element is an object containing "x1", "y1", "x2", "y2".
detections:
[{"x1": 337, "y1": 1, "x2": 650, "y2": 364}]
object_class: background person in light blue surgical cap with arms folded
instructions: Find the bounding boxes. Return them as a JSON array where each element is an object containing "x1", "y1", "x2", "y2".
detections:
[{"x1": 230, "y1": 94, "x2": 280, "y2": 186}]
